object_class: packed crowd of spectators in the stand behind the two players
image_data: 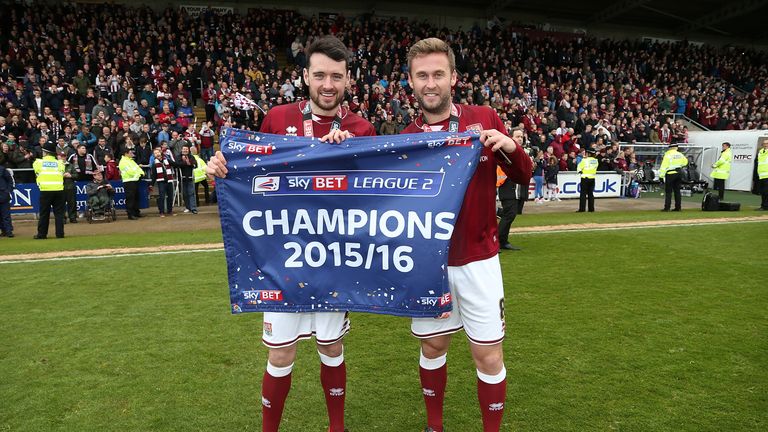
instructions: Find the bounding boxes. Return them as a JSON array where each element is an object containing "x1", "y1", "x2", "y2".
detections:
[{"x1": 0, "y1": 3, "x2": 768, "y2": 182}]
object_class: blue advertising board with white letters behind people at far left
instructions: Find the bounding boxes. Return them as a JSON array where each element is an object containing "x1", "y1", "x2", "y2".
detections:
[{"x1": 11, "y1": 181, "x2": 149, "y2": 214}]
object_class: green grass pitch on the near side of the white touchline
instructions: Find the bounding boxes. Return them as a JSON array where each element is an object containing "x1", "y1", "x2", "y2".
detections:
[{"x1": 0, "y1": 221, "x2": 768, "y2": 432}]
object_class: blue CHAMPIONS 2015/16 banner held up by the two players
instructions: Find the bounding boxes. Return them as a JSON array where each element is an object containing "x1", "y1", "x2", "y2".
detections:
[{"x1": 216, "y1": 129, "x2": 482, "y2": 317}]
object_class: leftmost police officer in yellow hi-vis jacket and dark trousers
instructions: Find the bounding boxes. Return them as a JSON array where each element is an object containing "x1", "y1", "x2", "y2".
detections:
[{"x1": 32, "y1": 141, "x2": 65, "y2": 240}]
